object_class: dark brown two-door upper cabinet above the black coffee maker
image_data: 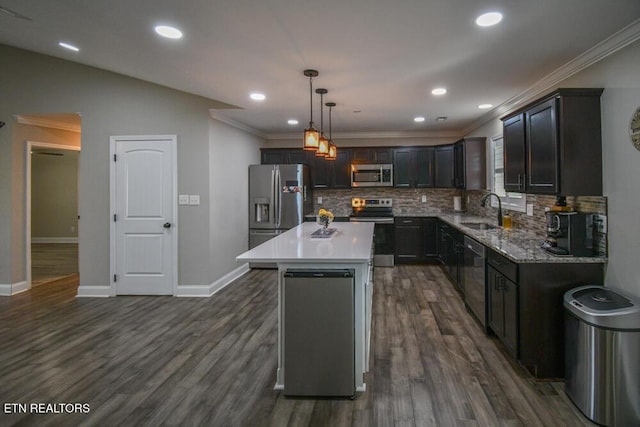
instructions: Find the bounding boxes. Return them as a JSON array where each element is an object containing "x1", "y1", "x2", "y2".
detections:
[{"x1": 502, "y1": 89, "x2": 603, "y2": 196}]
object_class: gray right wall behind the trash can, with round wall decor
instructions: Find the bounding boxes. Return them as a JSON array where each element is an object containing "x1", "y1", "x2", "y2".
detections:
[{"x1": 470, "y1": 42, "x2": 640, "y2": 296}]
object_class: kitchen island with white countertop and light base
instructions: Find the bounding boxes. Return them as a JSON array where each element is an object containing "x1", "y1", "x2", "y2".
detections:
[{"x1": 236, "y1": 222, "x2": 374, "y2": 392}]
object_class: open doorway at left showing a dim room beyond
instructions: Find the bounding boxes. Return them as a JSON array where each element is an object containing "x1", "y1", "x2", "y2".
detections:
[{"x1": 18, "y1": 114, "x2": 80, "y2": 289}]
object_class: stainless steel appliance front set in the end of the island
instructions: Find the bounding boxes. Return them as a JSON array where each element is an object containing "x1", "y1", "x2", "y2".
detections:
[{"x1": 283, "y1": 269, "x2": 355, "y2": 397}]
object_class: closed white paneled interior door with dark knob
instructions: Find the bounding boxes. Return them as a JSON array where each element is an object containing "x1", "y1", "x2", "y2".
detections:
[{"x1": 112, "y1": 136, "x2": 177, "y2": 295}]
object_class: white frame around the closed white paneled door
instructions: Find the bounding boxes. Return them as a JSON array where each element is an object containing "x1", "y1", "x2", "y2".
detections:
[{"x1": 109, "y1": 135, "x2": 179, "y2": 296}]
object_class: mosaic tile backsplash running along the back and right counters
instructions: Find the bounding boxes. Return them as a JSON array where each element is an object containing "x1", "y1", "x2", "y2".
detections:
[{"x1": 313, "y1": 188, "x2": 607, "y2": 255}]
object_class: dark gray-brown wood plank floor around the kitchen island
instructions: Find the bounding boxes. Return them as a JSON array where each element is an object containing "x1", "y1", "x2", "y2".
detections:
[{"x1": 0, "y1": 266, "x2": 592, "y2": 426}]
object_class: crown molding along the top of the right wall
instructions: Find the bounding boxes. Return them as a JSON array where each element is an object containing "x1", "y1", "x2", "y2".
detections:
[{"x1": 463, "y1": 19, "x2": 640, "y2": 135}]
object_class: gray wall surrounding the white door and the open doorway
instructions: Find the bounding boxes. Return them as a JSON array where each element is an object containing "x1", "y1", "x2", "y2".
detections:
[{"x1": 0, "y1": 45, "x2": 259, "y2": 286}]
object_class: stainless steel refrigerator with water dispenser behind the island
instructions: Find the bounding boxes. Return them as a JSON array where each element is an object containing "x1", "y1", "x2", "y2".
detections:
[{"x1": 249, "y1": 164, "x2": 313, "y2": 249}]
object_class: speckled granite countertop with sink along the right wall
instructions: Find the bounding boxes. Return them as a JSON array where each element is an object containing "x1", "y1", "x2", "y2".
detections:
[{"x1": 434, "y1": 214, "x2": 607, "y2": 264}]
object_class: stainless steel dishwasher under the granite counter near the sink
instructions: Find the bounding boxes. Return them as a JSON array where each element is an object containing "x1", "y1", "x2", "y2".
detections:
[{"x1": 463, "y1": 236, "x2": 487, "y2": 327}]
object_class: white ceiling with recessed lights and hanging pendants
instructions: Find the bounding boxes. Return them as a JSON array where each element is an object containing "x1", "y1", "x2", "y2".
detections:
[{"x1": 0, "y1": 0, "x2": 640, "y2": 138}]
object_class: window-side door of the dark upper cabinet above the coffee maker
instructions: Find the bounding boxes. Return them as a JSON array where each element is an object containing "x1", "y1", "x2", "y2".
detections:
[{"x1": 502, "y1": 114, "x2": 526, "y2": 193}]
